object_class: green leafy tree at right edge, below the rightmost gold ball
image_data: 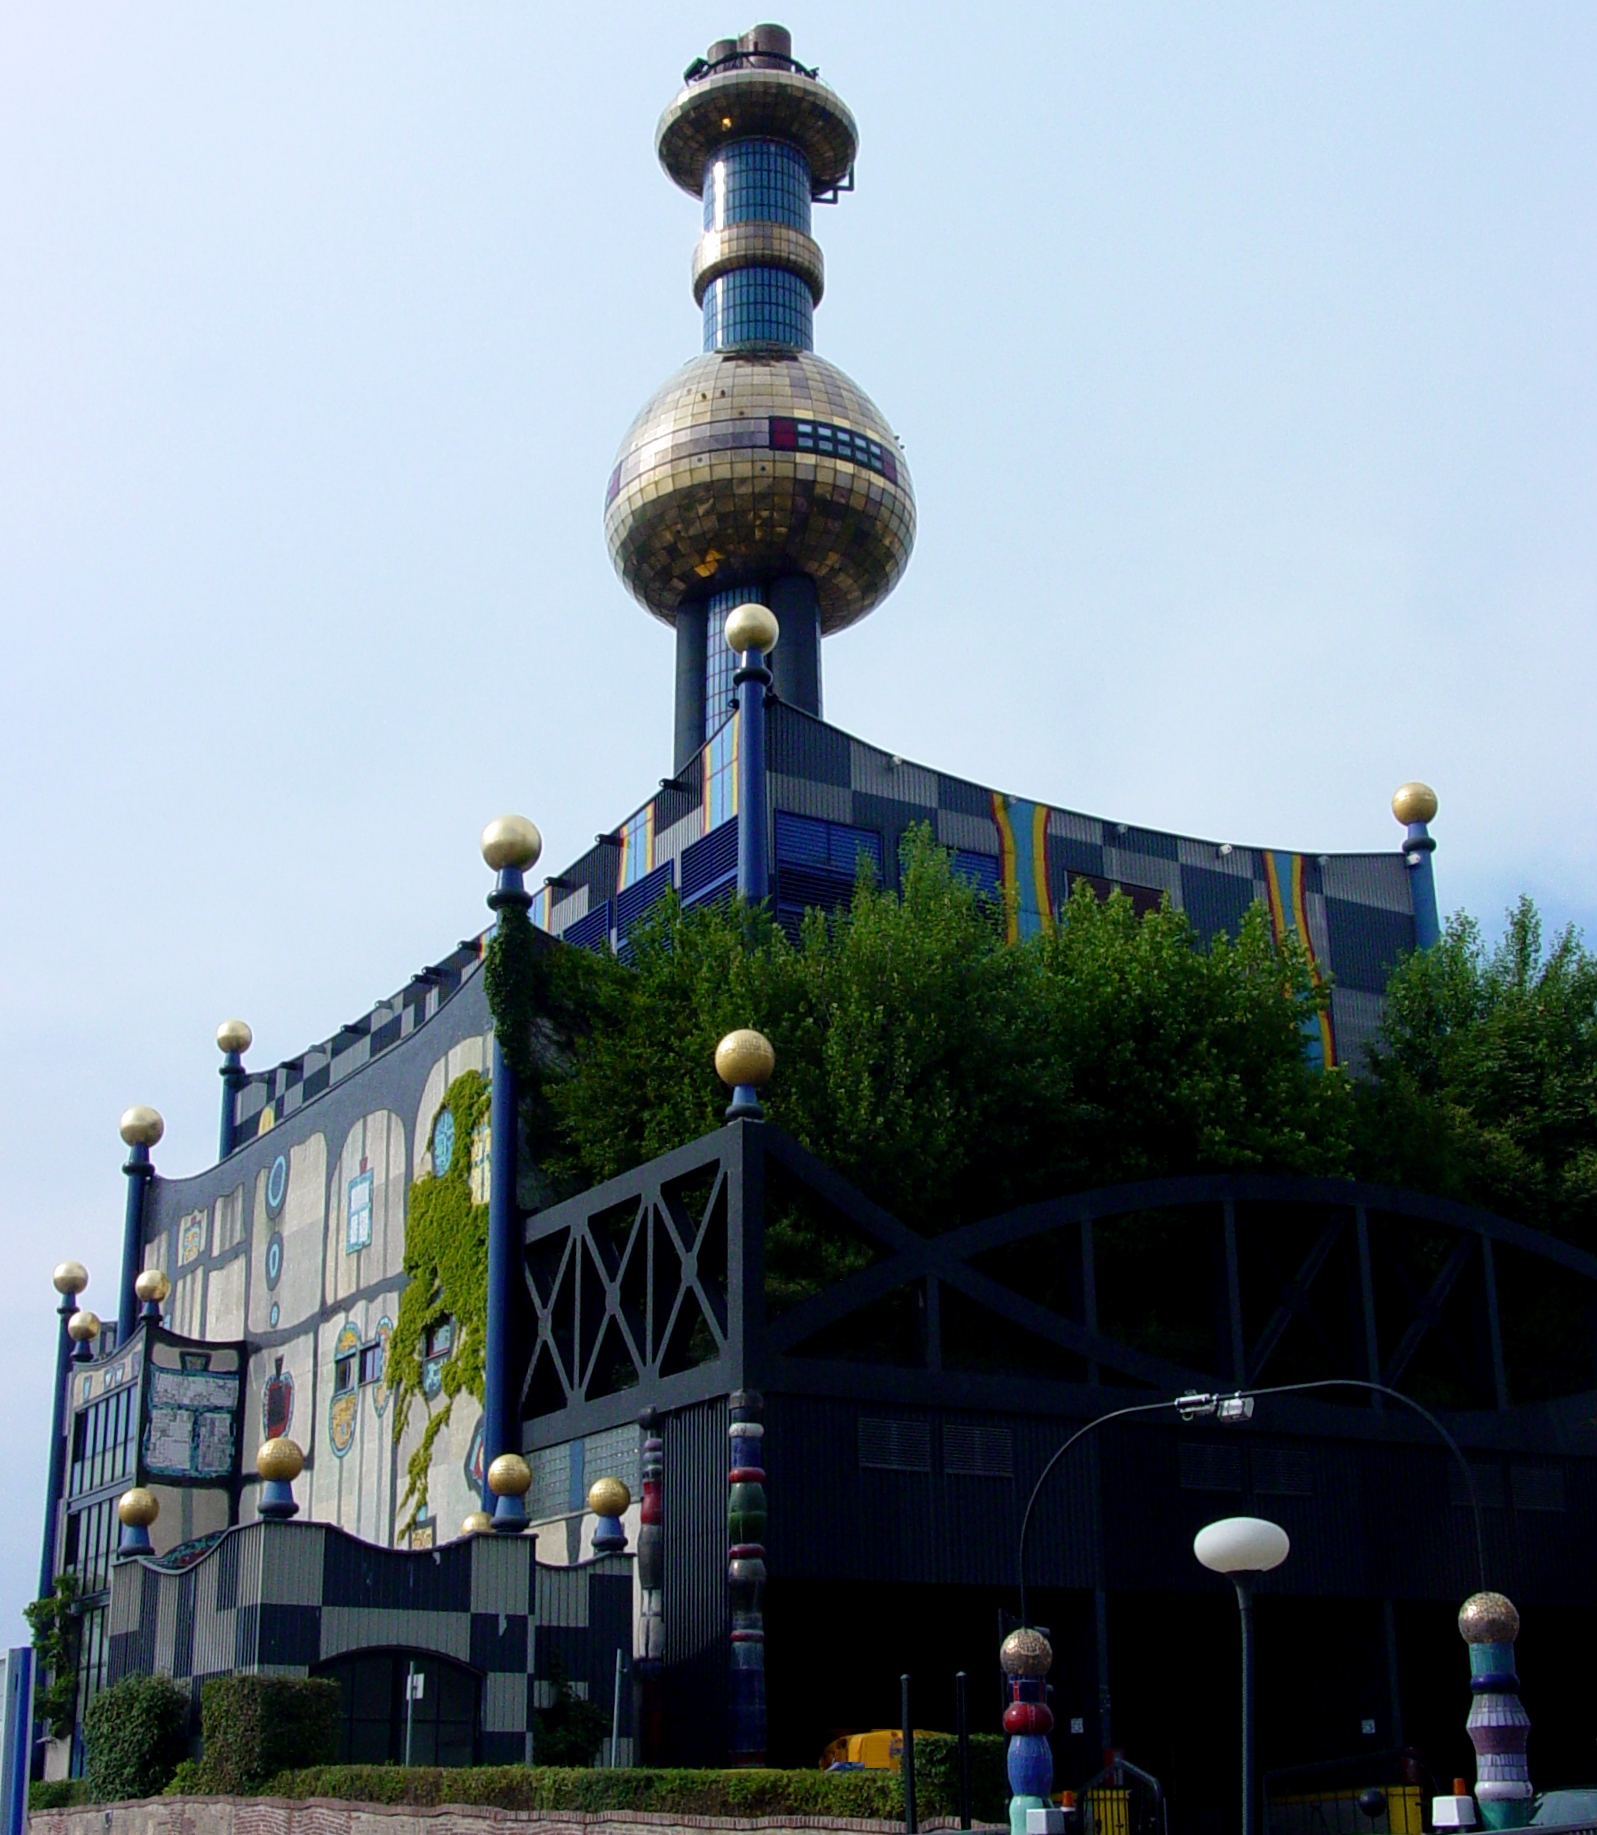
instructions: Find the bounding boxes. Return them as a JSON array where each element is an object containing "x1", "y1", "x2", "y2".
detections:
[{"x1": 1357, "y1": 897, "x2": 1597, "y2": 1248}]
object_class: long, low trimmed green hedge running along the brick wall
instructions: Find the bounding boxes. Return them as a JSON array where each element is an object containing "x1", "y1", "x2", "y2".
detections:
[{"x1": 262, "y1": 1741, "x2": 914, "y2": 1822}]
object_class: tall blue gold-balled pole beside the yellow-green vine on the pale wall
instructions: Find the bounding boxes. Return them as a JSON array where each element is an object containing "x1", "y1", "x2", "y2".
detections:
[{"x1": 481, "y1": 815, "x2": 543, "y2": 1530}]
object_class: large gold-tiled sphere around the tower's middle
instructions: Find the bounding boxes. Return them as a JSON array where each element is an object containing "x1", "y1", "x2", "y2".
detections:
[{"x1": 604, "y1": 349, "x2": 914, "y2": 633}]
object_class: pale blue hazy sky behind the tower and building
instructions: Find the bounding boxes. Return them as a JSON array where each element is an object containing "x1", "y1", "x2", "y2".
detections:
[{"x1": 0, "y1": 0, "x2": 1597, "y2": 1642}]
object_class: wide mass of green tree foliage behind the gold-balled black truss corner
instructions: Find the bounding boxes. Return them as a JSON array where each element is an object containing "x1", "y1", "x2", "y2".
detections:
[{"x1": 529, "y1": 829, "x2": 1351, "y2": 1285}]
